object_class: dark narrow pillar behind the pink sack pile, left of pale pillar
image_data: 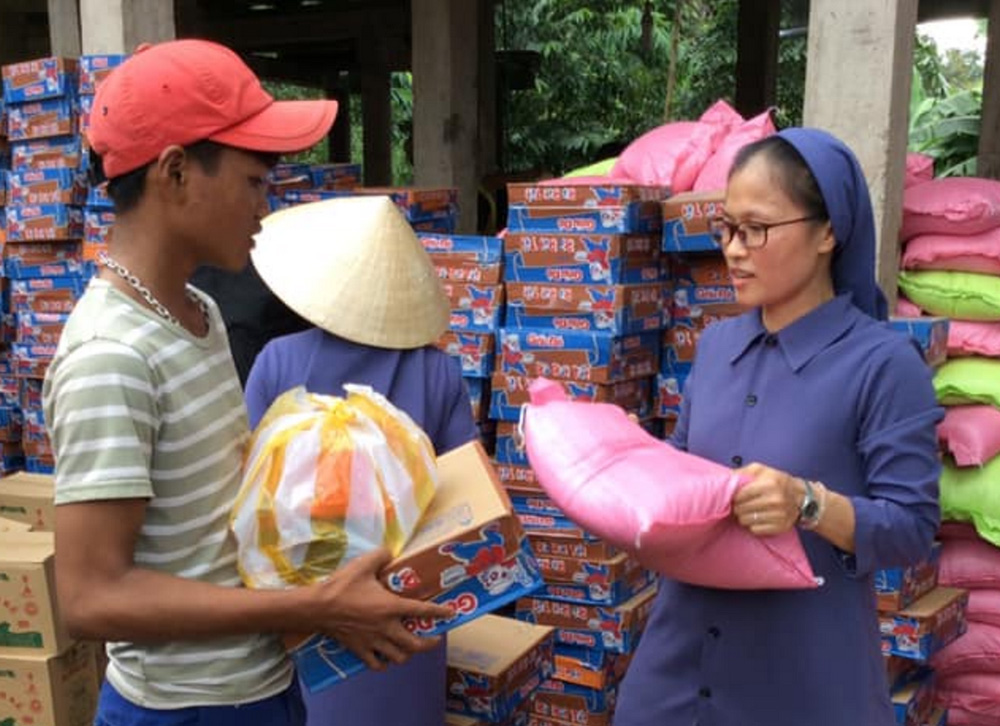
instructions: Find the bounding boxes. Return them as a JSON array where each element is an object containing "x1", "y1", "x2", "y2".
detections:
[{"x1": 736, "y1": 0, "x2": 781, "y2": 118}]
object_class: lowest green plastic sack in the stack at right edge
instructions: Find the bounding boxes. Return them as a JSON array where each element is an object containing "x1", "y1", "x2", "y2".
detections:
[{"x1": 941, "y1": 456, "x2": 1000, "y2": 547}]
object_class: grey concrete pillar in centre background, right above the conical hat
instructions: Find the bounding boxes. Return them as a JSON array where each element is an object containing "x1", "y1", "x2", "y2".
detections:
[{"x1": 411, "y1": 0, "x2": 487, "y2": 233}]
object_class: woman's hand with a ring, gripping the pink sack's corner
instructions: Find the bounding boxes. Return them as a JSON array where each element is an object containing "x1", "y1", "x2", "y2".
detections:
[{"x1": 733, "y1": 462, "x2": 805, "y2": 537}]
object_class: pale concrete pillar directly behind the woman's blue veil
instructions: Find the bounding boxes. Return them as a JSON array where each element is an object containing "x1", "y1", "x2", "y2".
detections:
[{"x1": 803, "y1": 0, "x2": 917, "y2": 305}]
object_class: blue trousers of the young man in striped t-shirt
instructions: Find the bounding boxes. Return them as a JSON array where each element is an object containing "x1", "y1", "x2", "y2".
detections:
[{"x1": 94, "y1": 679, "x2": 306, "y2": 726}]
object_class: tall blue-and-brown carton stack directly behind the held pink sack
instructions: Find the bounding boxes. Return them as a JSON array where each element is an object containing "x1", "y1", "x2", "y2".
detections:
[{"x1": 482, "y1": 179, "x2": 668, "y2": 726}]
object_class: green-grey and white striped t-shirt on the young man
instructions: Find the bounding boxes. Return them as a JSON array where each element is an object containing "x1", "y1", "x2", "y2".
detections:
[{"x1": 44, "y1": 279, "x2": 292, "y2": 709}]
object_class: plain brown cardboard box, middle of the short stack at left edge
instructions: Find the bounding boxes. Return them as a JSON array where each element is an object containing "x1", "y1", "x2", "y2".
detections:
[{"x1": 0, "y1": 532, "x2": 72, "y2": 655}]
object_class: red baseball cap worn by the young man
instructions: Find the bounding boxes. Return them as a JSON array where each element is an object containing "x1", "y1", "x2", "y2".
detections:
[{"x1": 87, "y1": 40, "x2": 337, "y2": 179}]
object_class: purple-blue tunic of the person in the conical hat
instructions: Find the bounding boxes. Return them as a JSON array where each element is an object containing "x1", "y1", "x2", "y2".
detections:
[{"x1": 246, "y1": 328, "x2": 477, "y2": 726}]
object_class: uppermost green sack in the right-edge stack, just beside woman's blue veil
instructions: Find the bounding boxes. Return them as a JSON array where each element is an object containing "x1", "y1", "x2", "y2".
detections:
[{"x1": 899, "y1": 270, "x2": 1000, "y2": 320}]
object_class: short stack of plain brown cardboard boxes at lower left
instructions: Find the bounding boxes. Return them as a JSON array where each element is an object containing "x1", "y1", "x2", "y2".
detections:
[{"x1": 0, "y1": 474, "x2": 102, "y2": 726}]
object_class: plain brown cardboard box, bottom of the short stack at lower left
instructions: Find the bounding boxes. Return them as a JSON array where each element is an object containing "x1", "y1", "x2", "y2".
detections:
[{"x1": 0, "y1": 643, "x2": 98, "y2": 726}]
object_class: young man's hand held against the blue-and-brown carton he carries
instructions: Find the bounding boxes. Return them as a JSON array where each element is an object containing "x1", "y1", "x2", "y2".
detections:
[{"x1": 315, "y1": 549, "x2": 452, "y2": 670}]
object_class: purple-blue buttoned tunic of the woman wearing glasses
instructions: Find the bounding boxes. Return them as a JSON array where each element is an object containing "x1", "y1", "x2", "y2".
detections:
[{"x1": 615, "y1": 295, "x2": 942, "y2": 726}]
